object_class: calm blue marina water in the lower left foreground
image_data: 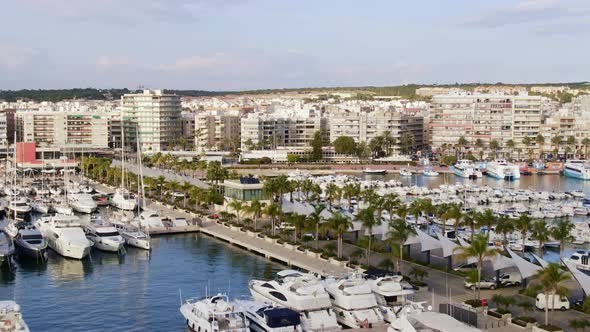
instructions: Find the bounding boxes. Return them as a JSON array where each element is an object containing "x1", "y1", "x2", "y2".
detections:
[{"x1": 0, "y1": 234, "x2": 284, "y2": 331}]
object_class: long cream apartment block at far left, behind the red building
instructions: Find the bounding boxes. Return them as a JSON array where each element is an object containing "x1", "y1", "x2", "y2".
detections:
[{"x1": 16, "y1": 111, "x2": 109, "y2": 149}]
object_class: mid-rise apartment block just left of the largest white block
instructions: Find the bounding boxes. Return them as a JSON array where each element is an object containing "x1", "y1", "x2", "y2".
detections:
[{"x1": 329, "y1": 107, "x2": 424, "y2": 151}]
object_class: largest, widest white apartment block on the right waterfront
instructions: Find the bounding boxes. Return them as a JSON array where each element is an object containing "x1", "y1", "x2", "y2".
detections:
[{"x1": 429, "y1": 93, "x2": 542, "y2": 158}]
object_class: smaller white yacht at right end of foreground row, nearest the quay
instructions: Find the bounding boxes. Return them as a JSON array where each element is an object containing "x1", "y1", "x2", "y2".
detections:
[{"x1": 369, "y1": 276, "x2": 415, "y2": 323}]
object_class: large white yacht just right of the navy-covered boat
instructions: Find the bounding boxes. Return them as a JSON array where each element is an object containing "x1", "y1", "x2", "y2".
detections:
[{"x1": 249, "y1": 270, "x2": 340, "y2": 332}]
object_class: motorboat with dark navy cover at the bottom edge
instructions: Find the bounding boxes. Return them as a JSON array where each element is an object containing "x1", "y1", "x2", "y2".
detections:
[{"x1": 239, "y1": 301, "x2": 302, "y2": 332}]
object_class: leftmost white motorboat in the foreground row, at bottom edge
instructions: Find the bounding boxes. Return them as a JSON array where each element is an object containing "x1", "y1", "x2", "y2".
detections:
[{"x1": 180, "y1": 294, "x2": 250, "y2": 332}]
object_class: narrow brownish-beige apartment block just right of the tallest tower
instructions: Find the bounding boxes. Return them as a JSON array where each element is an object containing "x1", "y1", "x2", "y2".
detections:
[{"x1": 193, "y1": 111, "x2": 241, "y2": 151}]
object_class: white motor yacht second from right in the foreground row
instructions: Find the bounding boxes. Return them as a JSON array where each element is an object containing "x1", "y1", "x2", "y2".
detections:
[{"x1": 324, "y1": 275, "x2": 384, "y2": 328}]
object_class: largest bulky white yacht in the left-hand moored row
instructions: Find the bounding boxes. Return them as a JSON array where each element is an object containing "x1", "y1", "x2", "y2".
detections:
[{"x1": 37, "y1": 215, "x2": 93, "y2": 259}]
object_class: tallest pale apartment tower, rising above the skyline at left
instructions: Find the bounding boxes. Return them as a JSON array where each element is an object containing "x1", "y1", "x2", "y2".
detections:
[{"x1": 121, "y1": 90, "x2": 182, "y2": 152}]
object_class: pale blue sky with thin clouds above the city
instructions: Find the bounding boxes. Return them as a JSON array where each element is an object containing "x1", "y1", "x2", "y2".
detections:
[{"x1": 0, "y1": 0, "x2": 590, "y2": 91}]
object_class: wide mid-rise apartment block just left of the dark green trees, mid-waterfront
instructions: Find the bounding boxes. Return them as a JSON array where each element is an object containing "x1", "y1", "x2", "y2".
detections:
[{"x1": 241, "y1": 109, "x2": 329, "y2": 149}]
